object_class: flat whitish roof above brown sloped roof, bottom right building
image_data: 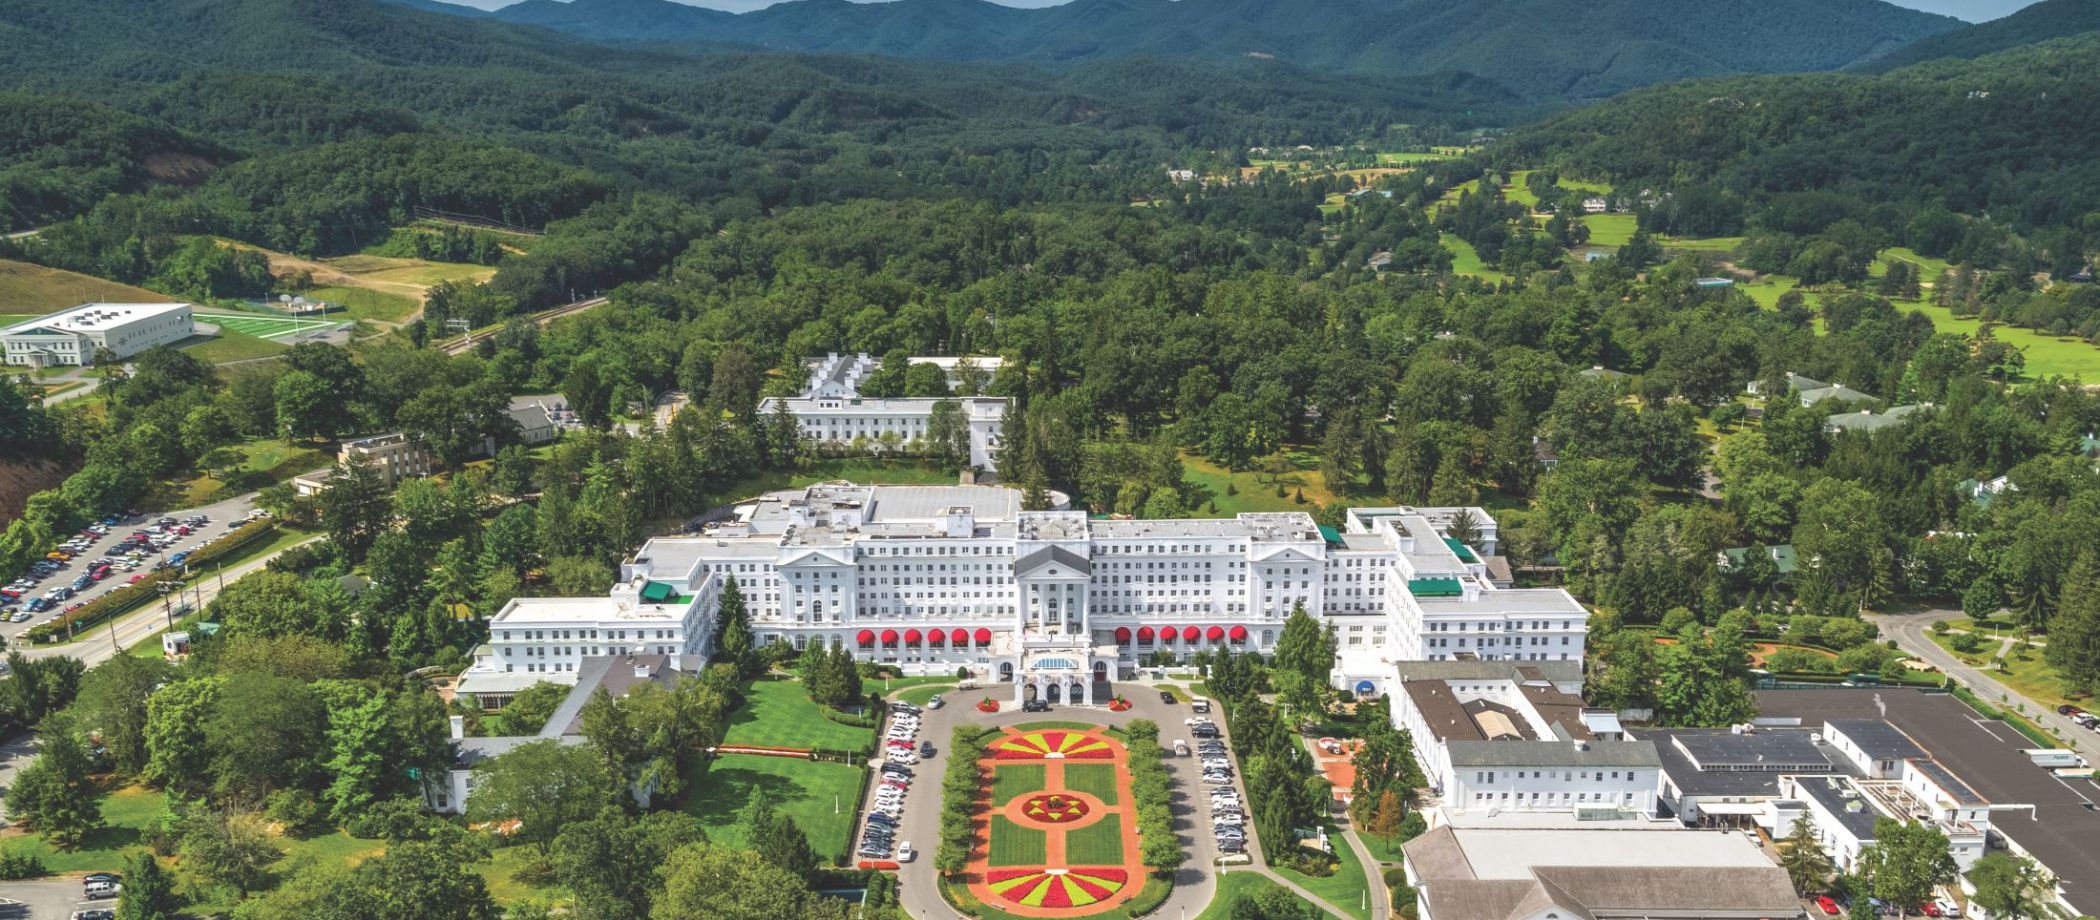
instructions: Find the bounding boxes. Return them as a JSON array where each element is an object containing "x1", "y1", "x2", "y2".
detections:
[{"x1": 1451, "y1": 828, "x2": 1772, "y2": 882}]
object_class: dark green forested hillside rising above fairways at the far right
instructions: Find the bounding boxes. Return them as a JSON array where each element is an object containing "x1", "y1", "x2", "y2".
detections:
[{"x1": 1493, "y1": 34, "x2": 2100, "y2": 239}]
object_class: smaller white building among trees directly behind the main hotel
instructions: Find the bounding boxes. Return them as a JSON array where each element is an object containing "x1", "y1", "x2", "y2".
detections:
[{"x1": 760, "y1": 353, "x2": 1008, "y2": 471}]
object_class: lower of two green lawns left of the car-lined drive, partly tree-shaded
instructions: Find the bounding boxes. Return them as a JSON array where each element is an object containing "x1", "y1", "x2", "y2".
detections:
[{"x1": 685, "y1": 754, "x2": 861, "y2": 859}]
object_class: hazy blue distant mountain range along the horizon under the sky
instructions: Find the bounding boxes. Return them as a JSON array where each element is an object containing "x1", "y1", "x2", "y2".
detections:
[{"x1": 426, "y1": 0, "x2": 1961, "y2": 99}]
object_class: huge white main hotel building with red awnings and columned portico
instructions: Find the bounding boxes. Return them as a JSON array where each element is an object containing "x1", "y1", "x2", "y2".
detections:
[{"x1": 462, "y1": 483, "x2": 1588, "y2": 702}]
